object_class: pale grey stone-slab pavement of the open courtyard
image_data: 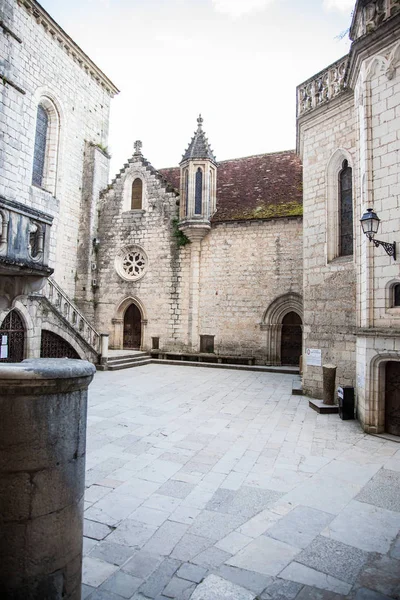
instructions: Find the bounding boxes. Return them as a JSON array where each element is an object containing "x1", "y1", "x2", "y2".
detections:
[{"x1": 82, "y1": 365, "x2": 400, "y2": 600}]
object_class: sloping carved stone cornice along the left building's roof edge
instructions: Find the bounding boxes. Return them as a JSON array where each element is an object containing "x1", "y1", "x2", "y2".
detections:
[{"x1": 17, "y1": 0, "x2": 119, "y2": 97}]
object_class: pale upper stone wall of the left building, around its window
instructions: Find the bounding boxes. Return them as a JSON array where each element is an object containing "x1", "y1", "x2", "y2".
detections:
[{"x1": 0, "y1": 0, "x2": 113, "y2": 296}]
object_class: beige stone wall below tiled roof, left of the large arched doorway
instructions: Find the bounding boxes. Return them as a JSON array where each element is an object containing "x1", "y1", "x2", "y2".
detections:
[{"x1": 199, "y1": 218, "x2": 303, "y2": 362}]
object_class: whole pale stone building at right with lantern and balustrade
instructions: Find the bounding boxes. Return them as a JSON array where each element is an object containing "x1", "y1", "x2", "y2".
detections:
[{"x1": 297, "y1": 0, "x2": 400, "y2": 435}]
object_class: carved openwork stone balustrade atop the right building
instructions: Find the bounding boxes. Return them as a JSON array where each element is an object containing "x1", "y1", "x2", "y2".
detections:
[{"x1": 297, "y1": 55, "x2": 349, "y2": 117}]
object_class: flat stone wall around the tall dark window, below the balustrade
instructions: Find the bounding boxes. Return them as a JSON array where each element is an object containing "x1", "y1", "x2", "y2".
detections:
[{"x1": 299, "y1": 92, "x2": 359, "y2": 397}]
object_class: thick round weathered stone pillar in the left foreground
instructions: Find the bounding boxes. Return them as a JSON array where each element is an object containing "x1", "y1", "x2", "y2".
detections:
[{"x1": 0, "y1": 359, "x2": 95, "y2": 600}]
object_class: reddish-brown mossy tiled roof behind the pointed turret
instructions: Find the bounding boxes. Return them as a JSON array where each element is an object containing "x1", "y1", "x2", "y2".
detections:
[{"x1": 160, "y1": 150, "x2": 303, "y2": 222}]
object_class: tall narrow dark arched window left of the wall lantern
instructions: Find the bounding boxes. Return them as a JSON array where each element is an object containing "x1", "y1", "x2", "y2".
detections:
[{"x1": 339, "y1": 160, "x2": 353, "y2": 256}]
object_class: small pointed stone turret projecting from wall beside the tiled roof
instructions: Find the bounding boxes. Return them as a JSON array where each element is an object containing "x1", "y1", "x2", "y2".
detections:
[{"x1": 179, "y1": 115, "x2": 217, "y2": 242}]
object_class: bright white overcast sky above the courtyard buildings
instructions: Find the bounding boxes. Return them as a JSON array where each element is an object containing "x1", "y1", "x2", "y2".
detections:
[{"x1": 39, "y1": 0, "x2": 355, "y2": 175}]
